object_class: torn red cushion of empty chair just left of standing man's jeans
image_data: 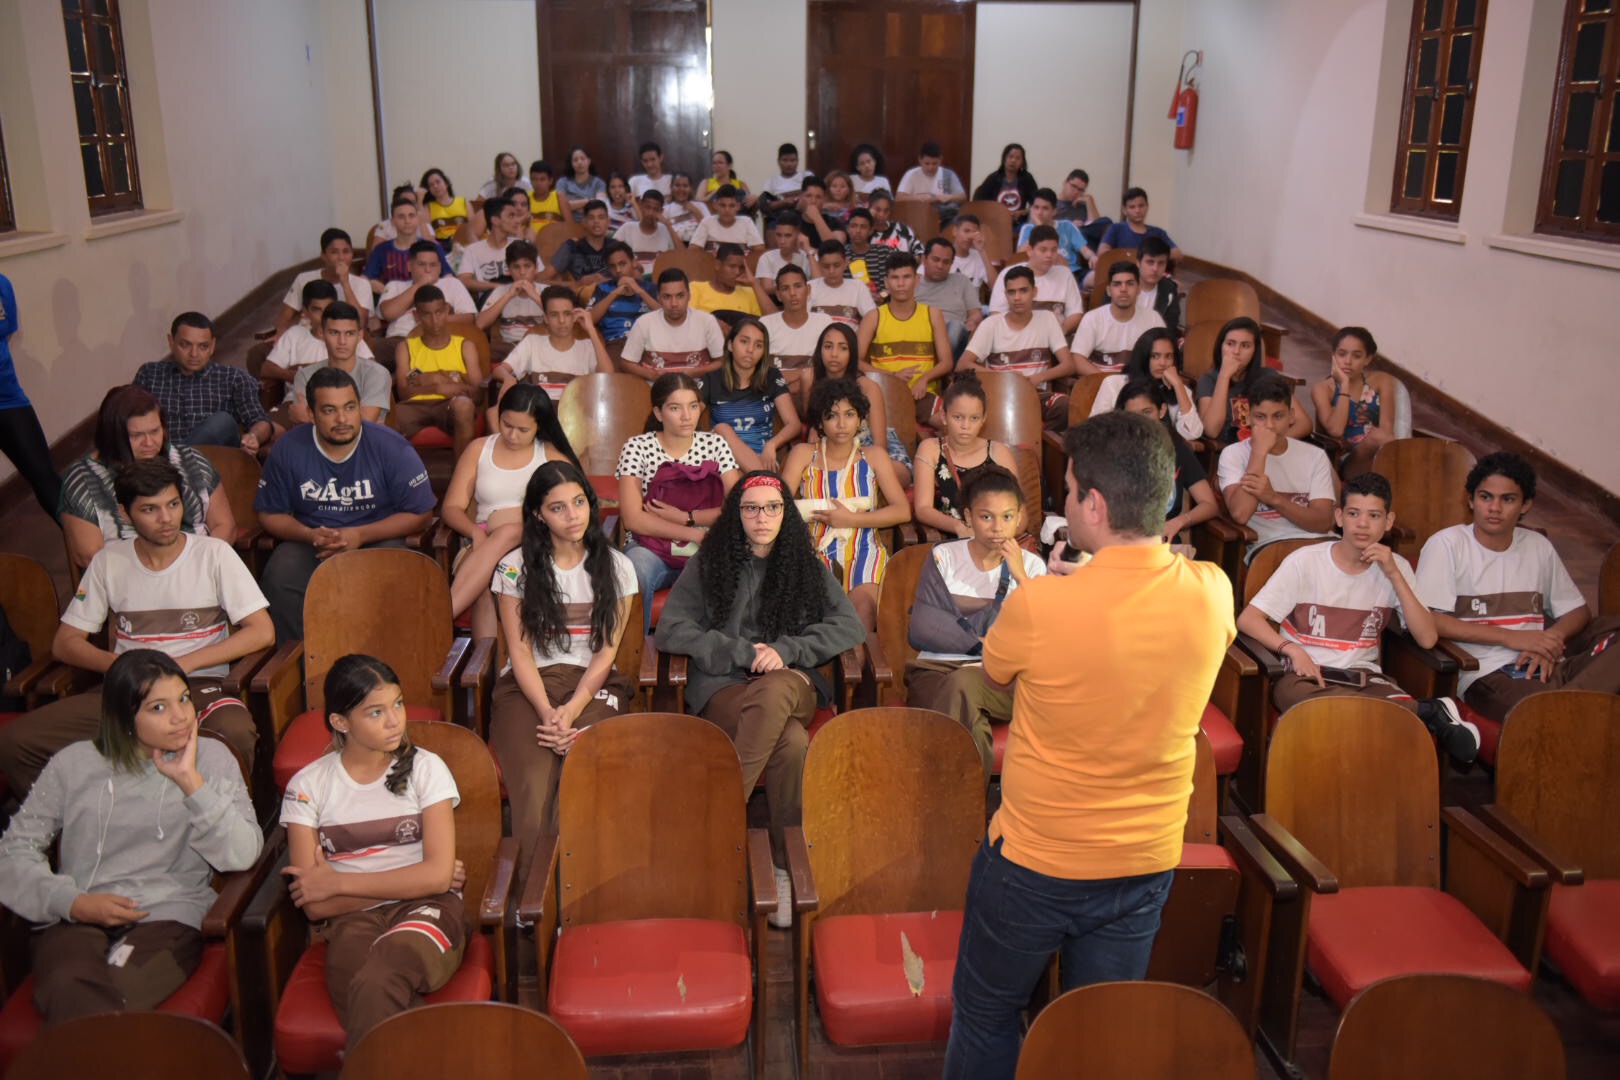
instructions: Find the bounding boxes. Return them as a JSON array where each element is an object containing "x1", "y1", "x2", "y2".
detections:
[{"x1": 810, "y1": 912, "x2": 962, "y2": 1046}]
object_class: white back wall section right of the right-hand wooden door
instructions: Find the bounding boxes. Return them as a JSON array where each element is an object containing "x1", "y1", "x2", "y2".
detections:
[{"x1": 964, "y1": 3, "x2": 1131, "y2": 201}]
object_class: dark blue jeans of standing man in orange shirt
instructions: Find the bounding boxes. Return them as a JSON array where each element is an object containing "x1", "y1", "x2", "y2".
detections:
[{"x1": 944, "y1": 837, "x2": 1175, "y2": 1080}]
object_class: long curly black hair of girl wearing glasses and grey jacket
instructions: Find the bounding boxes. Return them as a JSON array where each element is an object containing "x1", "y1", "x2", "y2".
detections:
[{"x1": 698, "y1": 470, "x2": 828, "y2": 641}]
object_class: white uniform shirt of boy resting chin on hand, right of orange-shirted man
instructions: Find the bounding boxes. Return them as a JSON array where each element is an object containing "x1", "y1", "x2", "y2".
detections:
[{"x1": 1249, "y1": 541, "x2": 1418, "y2": 672}]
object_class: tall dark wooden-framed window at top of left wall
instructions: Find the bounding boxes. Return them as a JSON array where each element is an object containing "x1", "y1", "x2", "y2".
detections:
[{"x1": 62, "y1": 0, "x2": 141, "y2": 215}]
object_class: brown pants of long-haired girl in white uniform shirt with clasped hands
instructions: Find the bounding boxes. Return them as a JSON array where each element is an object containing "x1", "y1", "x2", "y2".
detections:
[{"x1": 489, "y1": 664, "x2": 635, "y2": 874}]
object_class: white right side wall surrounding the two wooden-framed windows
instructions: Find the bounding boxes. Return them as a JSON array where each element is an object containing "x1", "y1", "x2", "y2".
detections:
[{"x1": 1149, "y1": 0, "x2": 1620, "y2": 491}]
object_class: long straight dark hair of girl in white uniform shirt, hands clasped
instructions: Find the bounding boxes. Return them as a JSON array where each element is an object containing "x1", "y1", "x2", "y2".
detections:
[{"x1": 518, "y1": 461, "x2": 619, "y2": 653}]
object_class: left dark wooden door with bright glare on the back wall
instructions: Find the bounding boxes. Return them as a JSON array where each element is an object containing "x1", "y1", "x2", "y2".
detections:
[{"x1": 536, "y1": 0, "x2": 713, "y2": 176}]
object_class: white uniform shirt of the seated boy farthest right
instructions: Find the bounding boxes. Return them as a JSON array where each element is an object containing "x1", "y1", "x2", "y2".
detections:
[{"x1": 1418, "y1": 525, "x2": 1586, "y2": 693}]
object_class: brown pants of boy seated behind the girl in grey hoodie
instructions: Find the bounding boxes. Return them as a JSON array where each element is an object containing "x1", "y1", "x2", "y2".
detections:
[{"x1": 0, "y1": 675, "x2": 259, "y2": 798}]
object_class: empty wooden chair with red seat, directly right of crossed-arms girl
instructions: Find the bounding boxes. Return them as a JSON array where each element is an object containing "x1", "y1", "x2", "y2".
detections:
[{"x1": 518, "y1": 712, "x2": 776, "y2": 1075}]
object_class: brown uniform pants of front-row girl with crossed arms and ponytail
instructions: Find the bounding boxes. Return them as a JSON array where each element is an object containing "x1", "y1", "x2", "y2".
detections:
[{"x1": 318, "y1": 892, "x2": 471, "y2": 1049}]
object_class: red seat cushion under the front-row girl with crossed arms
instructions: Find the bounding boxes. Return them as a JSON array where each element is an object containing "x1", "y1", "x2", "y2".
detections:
[{"x1": 275, "y1": 933, "x2": 494, "y2": 1075}]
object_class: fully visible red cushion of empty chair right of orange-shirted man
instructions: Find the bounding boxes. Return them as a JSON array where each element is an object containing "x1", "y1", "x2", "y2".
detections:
[{"x1": 1306, "y1": 886, "x2": 1529, "y2": 1009}]
